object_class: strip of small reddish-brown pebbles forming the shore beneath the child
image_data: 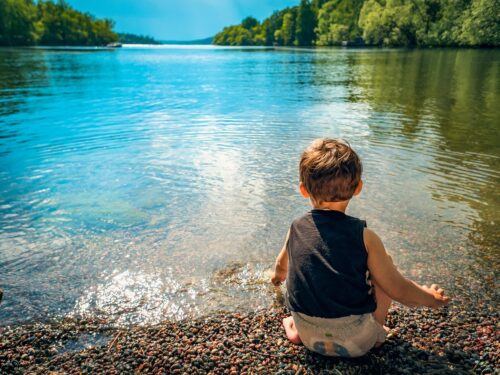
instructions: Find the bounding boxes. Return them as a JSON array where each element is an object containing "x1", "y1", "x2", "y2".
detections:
[{"x1": 0, "y1": 301, "x2": 500, "y2": 375}]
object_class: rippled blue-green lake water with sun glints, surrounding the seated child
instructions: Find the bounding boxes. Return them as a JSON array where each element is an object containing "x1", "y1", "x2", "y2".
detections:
[{"x1": 0, "y1": 47, "x2": 500, "y2": 325}]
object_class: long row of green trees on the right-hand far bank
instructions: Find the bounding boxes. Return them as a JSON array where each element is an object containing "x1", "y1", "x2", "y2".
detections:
[{"x1": 213, "y1": 0, "x2": 500, "y2": 47}]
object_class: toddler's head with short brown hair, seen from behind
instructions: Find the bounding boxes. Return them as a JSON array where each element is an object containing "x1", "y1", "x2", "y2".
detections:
[{"x1": 299, "y1": 138, "x2": 363, "y2": 203}]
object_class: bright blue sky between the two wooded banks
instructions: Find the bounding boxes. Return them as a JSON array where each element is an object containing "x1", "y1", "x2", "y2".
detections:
[{"x1": 67, "y1": 0, "x2": 299, "y2": 40}]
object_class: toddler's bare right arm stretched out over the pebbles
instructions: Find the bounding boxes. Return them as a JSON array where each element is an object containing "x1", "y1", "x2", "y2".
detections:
[{"x1": 364, "y1": 228, "x2": 450, "y2": 308}]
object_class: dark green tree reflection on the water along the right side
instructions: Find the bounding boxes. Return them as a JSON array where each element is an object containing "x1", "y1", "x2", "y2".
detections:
[{"x1": 338, "y1": 50, "x2": 500, "y2": 251}]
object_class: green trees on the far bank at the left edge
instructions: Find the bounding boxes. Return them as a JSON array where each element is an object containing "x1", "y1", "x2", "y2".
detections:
[{"x1": 0, "y1": 0, "x2": 118, "y2": 46}]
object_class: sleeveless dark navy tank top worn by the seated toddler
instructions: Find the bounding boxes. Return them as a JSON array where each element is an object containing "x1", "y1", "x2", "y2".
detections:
[{"x1": 286, "y1": 209, "x2": 377, "y2": 318}]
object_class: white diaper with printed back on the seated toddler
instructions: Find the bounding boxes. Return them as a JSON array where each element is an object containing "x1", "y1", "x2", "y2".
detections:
[{"x1": 292, "y1": 311, "x2": 386, "y2": 357}]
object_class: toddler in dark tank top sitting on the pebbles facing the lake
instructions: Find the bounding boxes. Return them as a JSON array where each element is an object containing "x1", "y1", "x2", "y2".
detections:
[{"x1": 271, "y1": 139, "x2": 450, "y2": 357}]
